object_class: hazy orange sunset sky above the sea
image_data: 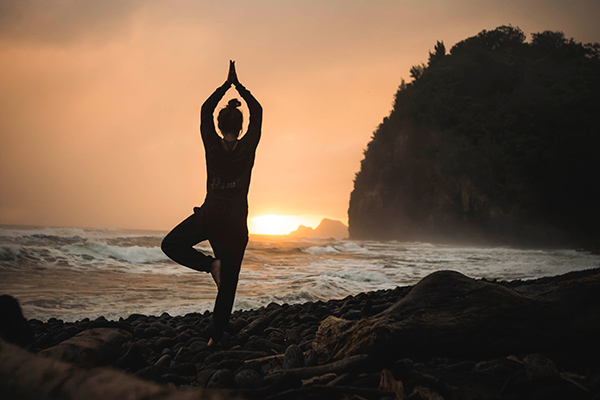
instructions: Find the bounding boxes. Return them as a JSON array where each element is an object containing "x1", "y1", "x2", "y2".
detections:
[{"x1": 0, "y1": 0, "x2": 600, "y2": 229}]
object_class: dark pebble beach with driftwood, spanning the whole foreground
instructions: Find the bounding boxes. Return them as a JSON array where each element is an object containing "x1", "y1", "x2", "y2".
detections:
[{"x1": 0, "y1": 269, "x2": 600, "y2": 400}]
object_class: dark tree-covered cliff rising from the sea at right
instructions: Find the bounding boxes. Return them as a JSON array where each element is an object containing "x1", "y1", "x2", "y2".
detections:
[{"x1": 348, "y1": 26, "x2": 600, "y2": 243}]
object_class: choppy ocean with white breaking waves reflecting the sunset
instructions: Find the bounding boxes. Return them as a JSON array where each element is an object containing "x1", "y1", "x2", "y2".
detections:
[{"x1": 0, "y1": 226, "x2": 600, "y2": 321}]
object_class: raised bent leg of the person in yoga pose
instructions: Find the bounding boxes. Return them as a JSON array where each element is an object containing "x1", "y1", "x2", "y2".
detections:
[{"x1": 161, "y1": 214, "x2": 215, "y2": 272}]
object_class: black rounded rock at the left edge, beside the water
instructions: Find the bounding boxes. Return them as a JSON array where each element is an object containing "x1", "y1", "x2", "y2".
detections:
[{"x1": 0, "y1": 294, "x2": 33, "y2": 347}]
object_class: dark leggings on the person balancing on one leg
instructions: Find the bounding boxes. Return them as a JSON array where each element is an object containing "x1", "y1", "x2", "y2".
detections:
[{"x1": 161, "y1": 201, "x2": 248, "y2": 341}]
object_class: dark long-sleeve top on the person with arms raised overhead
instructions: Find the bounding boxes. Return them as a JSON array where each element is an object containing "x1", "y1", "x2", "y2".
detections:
[{"x1": 200, "y1": 82, "x2": 262, "y2": 208}]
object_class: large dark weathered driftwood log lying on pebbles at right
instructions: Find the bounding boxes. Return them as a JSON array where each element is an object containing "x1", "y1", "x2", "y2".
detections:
[{"x1": 313, "y1": 271, "x2": 600, "y2": 361}]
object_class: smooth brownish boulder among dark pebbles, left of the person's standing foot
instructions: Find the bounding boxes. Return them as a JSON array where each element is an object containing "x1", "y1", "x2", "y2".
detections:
[{"x1": 39, "y1": 328, "x2": 132, "y2": 366}]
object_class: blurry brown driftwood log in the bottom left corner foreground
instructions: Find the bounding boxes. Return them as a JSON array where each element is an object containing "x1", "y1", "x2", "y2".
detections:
[{"x1": 0, "y1": 340, "x2": 239, "y2": 400}]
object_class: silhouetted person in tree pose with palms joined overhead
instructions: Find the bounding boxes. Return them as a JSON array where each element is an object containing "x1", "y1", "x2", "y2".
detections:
[{"x1": 161, "y1": 61, "x2": 262, "y2": 347}]
